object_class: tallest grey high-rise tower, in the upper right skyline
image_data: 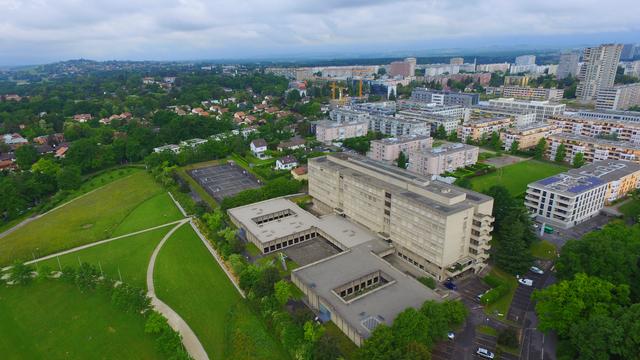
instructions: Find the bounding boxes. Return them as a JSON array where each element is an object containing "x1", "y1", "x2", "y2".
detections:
[{"x1": 576, "y1": 44, "x2": 622, "y2": 102}]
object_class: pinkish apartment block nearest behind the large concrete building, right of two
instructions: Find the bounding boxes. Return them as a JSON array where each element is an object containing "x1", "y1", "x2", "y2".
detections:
[{"x1": 407, "y1": 144, "x2": 480, "y2": 176}]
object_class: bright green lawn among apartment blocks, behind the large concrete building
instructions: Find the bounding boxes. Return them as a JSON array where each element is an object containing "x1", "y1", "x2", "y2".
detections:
[{"x1": 470, "y1": 160, "x2": 569, "y2": 196}]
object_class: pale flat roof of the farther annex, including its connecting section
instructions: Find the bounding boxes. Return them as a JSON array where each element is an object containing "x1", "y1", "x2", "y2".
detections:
[{"x1": 228, "y1": 198, "x2": 378, "y2": 248}]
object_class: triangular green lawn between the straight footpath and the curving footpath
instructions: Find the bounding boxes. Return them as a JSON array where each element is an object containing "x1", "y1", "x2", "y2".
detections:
[{"x1": 37, "y1": 225, "x2": 175, "y2": 289}]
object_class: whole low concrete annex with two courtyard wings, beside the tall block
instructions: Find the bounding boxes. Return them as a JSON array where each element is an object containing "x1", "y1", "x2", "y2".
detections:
[{"x1": 228, "y1": 198, "x2": 440, "y2": 346}]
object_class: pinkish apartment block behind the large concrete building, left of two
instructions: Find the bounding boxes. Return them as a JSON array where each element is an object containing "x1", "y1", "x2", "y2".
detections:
[{"x1": 367, "y1": 135, "x2": 433, "y2": 162}]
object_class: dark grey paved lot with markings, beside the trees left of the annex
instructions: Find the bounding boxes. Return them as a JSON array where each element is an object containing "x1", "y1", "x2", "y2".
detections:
[{"x1": 188, "y1": 164, "x2": 262, "y2": 201}]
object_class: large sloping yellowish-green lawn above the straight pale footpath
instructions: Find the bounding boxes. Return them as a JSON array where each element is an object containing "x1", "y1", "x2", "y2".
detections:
[{"x1": 0, "y1": 172, "x2": 182, "y2": 265}]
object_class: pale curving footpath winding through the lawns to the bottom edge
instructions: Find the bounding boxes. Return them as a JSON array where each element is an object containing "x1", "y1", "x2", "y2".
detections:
[{"x1": 147, "y1": 219, "x2": 209, "y2": 360}]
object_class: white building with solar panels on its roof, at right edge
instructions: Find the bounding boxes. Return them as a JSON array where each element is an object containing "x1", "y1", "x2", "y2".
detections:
[{"x1": 525, "y1": 160, "x2": 640, "y2": 229}]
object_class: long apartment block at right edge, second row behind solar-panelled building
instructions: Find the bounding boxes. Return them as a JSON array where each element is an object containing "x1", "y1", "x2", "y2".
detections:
[{"x1": 549, "y1": 115, "x2": 640, "y2": 143}]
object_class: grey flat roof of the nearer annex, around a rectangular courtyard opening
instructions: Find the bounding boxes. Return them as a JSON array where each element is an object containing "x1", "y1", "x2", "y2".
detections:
[{"x1": 292, "y1": 240, "x2": 441, "y2": 338}]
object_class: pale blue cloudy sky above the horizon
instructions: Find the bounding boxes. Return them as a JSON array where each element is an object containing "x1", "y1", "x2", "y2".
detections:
[{"x1": 0, "y1": 0, "x2": 640, "y2": 65}]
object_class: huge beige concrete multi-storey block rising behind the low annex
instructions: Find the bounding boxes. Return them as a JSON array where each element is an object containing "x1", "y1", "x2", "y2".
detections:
[{"x1": 309, "y1": 153, "x2": 494, "y2": 280}]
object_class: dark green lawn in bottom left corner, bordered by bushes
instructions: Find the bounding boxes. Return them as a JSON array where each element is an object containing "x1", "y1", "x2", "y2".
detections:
[{"x1": 0, "y1": 280, "x2": 166, "y2": 359}]
